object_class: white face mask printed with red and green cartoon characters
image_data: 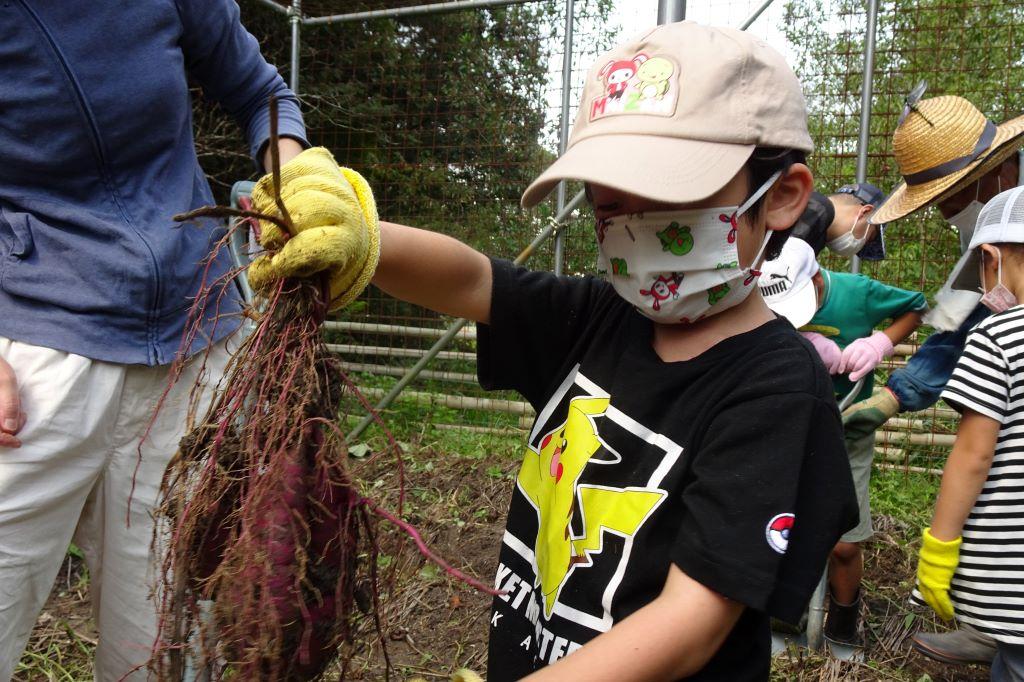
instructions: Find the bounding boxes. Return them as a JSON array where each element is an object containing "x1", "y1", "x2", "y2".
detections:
[{"x1": 597, "y1": 171, "x2": 781, "y2": 324}]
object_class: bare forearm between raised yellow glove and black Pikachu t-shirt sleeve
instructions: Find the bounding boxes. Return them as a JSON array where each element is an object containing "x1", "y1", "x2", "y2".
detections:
[{"x1": 373, "y1": 221, "x2": 493, "y2": 324}]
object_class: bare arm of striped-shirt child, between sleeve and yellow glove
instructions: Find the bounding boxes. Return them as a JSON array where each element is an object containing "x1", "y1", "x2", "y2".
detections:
[{"x1": 931, "y1": 409, "x2": 999, "y2": 542}]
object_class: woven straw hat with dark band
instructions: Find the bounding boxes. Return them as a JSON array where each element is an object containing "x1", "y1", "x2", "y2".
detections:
[{"x1": 870, "y1": 95, "x2": 1024, "y2": 224}]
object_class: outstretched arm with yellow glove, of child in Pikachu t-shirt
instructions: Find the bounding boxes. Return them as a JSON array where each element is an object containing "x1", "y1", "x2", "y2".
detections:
[{"x1": 243, "y1": 144, "x2": 492, "y2": 323}]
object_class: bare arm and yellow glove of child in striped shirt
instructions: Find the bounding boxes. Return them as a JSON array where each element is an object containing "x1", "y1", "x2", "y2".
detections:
[{"x1": 918, "y1": 408, "x2": 1000, "y2": 621}]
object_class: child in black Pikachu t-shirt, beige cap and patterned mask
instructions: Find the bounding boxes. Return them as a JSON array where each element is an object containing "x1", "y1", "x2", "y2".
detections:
[{"x1": 253, "y1": 23, "x2": 857, "y2": 682}]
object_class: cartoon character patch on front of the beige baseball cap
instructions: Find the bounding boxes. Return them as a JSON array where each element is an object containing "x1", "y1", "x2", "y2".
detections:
[{"x1": 590, "y1": 52, "x2": 679, "y2": 121}]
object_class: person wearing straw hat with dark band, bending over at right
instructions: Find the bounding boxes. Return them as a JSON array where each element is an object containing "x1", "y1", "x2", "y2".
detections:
[{"x1": 844, "y1": 89, "x2": 1024, "y2": 663}]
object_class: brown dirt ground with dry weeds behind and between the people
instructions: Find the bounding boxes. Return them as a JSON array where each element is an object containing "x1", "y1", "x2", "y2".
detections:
[{"x1": 14, "y1": 440, "x2": 987, "y2": 682}]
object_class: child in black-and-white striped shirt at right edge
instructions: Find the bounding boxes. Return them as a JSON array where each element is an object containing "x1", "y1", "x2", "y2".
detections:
[{"x1": 914, "y1": 187, "x2": 1024, "y2": 681}]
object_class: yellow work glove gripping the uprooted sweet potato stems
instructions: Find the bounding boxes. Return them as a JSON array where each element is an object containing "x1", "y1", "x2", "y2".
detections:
[{"x1": 249, "y1": 146, "x2": 380, "y2": 310}]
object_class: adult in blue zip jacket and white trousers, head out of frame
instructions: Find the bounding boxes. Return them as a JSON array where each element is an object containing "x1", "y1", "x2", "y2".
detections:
[{"x1": 0, "y1": 0, "x2": 306, "y2": 680}]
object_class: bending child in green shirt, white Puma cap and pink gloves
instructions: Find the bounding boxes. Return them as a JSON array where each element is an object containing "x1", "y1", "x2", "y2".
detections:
[{"x1": 759, "y1": 239, "x2": 928, "y2": 656}]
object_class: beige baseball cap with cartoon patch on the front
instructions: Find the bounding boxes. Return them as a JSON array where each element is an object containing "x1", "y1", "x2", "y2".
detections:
[{"x1": 522, "y1": 22, "x2": 813, "y2": 208}]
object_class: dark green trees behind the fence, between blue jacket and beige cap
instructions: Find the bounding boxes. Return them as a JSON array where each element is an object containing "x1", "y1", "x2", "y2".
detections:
[{"x1": 196, "y1": 0, "x2": 611, "y2": 261}]
